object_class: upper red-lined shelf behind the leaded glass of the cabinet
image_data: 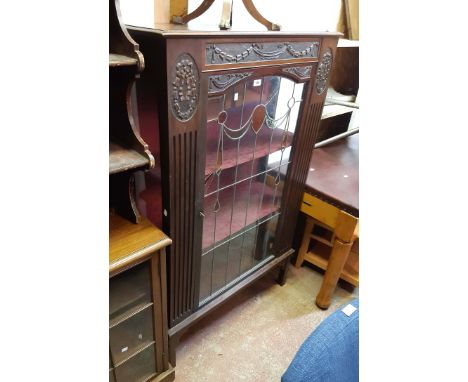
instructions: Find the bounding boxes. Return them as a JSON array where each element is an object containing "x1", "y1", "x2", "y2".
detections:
[{"x1": 205, "y1": 129, "x2": 294, "y2": 177}]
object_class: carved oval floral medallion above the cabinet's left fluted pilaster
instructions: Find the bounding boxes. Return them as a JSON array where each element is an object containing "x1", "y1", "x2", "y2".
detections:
[{"x1": 170, "y1": 53, "x2": 200, "y2": 121}]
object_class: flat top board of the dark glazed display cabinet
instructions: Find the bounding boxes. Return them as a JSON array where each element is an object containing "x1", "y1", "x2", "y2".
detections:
[{"x1": 126, "y1": 24, "x2": 343, "y2": 38}]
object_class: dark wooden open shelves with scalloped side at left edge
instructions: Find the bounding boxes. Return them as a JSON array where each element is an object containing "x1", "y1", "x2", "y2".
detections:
[{"x1": 109, "y1": 0, "x2": 154, "y2": 223}]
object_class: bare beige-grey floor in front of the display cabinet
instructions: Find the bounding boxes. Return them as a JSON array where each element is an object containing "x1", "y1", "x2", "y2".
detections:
[{"x1": 175, "y1": 264, "x2": 358, "y2": 382}]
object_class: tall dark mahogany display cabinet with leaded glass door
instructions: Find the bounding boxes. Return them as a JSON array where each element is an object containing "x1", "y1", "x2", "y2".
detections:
[{"x1": 128, "y1": 25, "x2": 339, "y2": 362}]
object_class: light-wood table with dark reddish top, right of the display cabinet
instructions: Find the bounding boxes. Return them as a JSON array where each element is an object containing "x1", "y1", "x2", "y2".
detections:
[{"x1": 295, "y1": 134, "x2": 359, "y2": 309}]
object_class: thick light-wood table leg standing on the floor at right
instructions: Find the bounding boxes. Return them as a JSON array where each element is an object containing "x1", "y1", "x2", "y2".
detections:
[{"x1": 315, "y1": 239, "x2": 353, "y2": 309}]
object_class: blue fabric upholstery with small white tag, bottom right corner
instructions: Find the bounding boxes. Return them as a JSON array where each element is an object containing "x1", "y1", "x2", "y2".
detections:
[{"x1": 281, "y1": 299, "x2": 359, "y2": 382}]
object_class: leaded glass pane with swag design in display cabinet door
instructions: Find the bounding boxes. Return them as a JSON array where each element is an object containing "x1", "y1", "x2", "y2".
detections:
[{"x1": 200, "y1": 76, "x2": 303, "y2": 305}]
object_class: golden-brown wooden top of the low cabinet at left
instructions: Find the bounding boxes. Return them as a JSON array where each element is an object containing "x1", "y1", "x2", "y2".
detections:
[{"x1": 109, "y1": 214, "x2": 172, "y2": 275}]
